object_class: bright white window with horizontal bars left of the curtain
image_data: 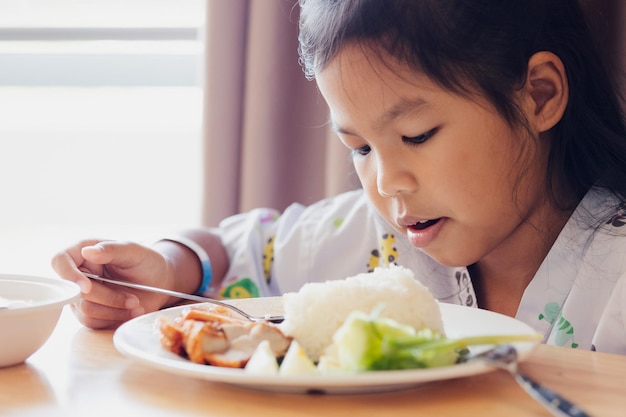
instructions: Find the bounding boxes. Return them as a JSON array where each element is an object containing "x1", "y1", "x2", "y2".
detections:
[{"x1": 0, "y1": 0, "x2": 205, "y2": 275}]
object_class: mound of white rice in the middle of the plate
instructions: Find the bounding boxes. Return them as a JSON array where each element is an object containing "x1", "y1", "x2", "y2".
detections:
[{"x1": 280, "y1": 266, "x2": 443, "y2": 361}]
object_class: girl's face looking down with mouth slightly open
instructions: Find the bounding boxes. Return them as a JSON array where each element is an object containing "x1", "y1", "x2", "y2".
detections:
[{"x1": 316, "y1": 47, "x2": 550, "y2": 266}]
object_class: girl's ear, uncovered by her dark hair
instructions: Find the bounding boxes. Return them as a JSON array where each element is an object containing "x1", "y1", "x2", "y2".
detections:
[{"x1": 524, "y1": 51, "x2": 569, "y2": 132}]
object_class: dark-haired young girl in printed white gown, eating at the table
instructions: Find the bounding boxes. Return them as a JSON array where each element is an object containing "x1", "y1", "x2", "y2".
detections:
[{"x1": 53, "y1": 0, "x2": 626, "y2": 354}]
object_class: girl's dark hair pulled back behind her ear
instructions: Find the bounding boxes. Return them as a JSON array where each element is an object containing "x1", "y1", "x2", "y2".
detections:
[{"x1": 299, "y1": 0, "x2": 626, "y2": 208}]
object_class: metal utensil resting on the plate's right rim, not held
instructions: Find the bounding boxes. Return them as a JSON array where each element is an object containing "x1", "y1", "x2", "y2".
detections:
[{"x1": 466, "y1": 345, "x2": 590, "y2": 417}]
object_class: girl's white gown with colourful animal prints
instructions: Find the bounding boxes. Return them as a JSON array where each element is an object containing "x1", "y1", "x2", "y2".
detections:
[{"x1": 210, "y1": 190, "x2": 626, "y2": 354}]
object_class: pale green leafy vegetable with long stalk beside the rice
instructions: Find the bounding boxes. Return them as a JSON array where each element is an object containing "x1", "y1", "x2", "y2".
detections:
[{"x1": 332, "y1": 312, "x2": 537, "y2": 371}]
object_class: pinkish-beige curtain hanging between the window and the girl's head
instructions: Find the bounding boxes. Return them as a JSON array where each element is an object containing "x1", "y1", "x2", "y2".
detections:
[{"x1": 202, "y1": 0, "x2": 358, "y2": 226}]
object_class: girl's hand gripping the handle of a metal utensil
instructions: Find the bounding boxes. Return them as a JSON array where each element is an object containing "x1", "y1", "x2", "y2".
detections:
[{"x1": 52, "y1": 240, "x2": 174, "y2": 329}]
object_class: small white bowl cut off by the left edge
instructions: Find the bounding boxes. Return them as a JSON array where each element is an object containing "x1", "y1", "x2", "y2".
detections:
[{"x1": 0, "y1": 274, "x2": 80, "y2": 368}]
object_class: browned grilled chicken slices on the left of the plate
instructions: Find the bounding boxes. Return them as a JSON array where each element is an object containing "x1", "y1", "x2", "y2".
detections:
[{"x1": 159, "y1": 306, "x2": 291, "y2": 368}]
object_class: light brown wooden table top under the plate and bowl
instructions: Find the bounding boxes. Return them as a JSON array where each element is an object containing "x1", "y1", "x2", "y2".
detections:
[{"x1": 0, "y1": 300, "x2": 626, "y2": 417}]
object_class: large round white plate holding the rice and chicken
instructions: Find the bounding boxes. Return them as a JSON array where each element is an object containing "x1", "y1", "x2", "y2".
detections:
[{"x1": 113, "y1": 304, "x2": 536, "y2": 394}]
